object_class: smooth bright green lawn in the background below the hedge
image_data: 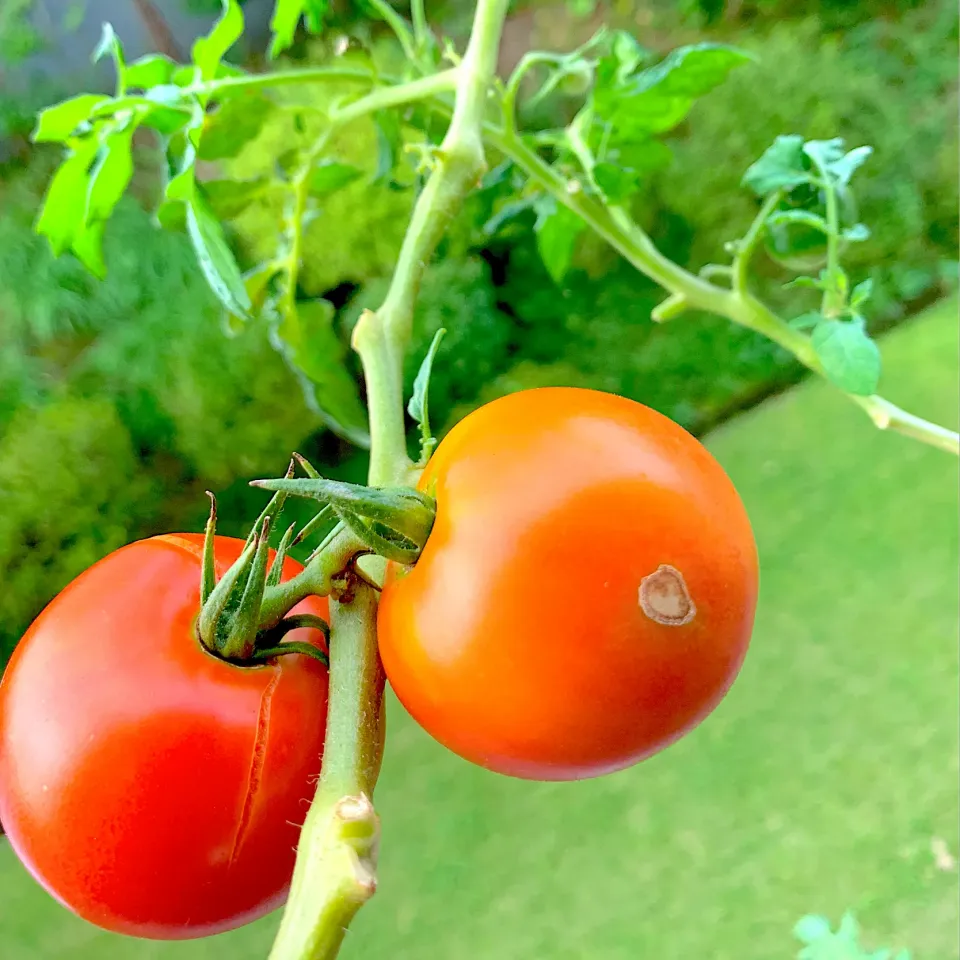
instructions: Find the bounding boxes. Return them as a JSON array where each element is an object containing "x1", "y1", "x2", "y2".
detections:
[{"x1": 0, "y1": 302, "x2": 960, "y2": 960}]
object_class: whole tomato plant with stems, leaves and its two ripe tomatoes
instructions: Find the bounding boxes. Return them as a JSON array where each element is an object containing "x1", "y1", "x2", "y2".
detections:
[{"x1": 0, "y1": 0, "x2": 960, "y2": 960}]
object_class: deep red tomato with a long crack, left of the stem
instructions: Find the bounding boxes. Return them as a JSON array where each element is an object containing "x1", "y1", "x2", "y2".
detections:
[{"x1": 0, "y1": 534, "x2": 327, "y2": 939}]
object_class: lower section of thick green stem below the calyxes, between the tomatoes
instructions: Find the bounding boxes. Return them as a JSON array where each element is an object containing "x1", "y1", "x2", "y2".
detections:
[{"x1": 270, "y1": 584, "x2": 383, "y2": 960}]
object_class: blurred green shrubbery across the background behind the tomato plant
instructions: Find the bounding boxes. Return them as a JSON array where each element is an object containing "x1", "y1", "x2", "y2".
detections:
[{"x1": 0, "y1": 0, "x2": 957, "y2": 657}]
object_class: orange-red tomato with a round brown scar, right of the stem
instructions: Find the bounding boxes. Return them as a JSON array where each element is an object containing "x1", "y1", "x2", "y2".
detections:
[{"x1": 378, "y1": 388, "x2": 757, "y2": 780}]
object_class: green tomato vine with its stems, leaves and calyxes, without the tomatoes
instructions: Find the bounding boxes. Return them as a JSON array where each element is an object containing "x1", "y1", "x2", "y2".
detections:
[{"x1": 9, "y1": 0, "x2": 960, "y2": 960}]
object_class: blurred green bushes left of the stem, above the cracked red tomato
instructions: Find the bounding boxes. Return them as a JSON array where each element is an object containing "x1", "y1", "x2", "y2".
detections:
[{"x1": 0, "y1": 171, "x2": 318, "y2": 655}]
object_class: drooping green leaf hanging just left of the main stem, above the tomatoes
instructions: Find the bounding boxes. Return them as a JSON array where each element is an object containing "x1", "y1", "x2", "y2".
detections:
[{"x1": 276, "y1": 300, "x2": 370, "y2": 447}]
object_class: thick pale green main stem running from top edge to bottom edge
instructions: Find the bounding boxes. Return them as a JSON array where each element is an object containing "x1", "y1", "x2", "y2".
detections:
[{"x1": 270, "y1": 0, "x2": 508, "y2": 960}]
